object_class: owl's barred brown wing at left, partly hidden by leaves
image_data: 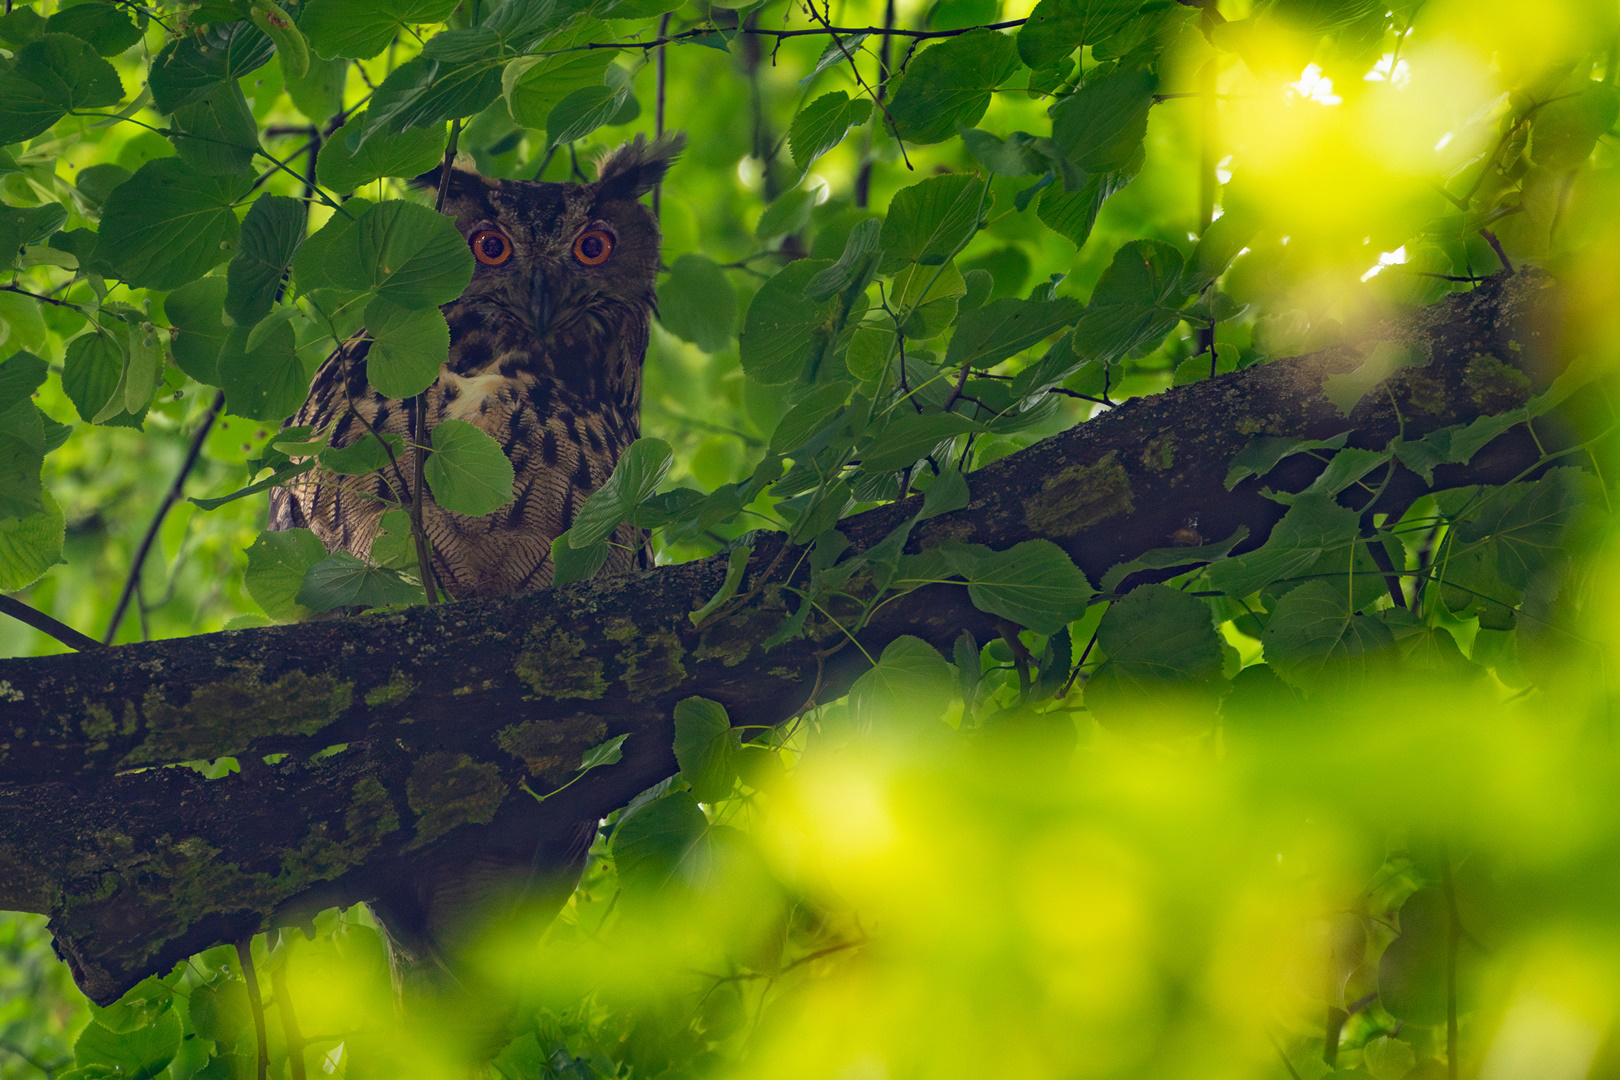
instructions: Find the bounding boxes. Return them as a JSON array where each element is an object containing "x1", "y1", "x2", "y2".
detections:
[{"x1": 269, "y1": 335, "x2": 410, "y2": 557}]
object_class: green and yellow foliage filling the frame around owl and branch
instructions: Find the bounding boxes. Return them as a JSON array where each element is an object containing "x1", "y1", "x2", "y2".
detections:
[{"x1": 0, "y1": 0, "x2": 1620, "y2": 1080}]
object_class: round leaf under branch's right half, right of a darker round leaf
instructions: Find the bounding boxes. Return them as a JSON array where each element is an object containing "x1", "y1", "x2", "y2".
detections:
[{"x1": 1260, "y1": 581, "x2": 1395, "y2": 691}]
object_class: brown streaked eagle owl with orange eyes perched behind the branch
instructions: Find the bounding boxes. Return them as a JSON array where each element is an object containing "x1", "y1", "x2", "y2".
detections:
[{"x1": 271, "y1": 136, "x2": 684, "y2": 975}]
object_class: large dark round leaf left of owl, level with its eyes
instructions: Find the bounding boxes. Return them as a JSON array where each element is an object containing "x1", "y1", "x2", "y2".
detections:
[{"x1": 97, "y1": 157, "x2": 253, "y2": 288}]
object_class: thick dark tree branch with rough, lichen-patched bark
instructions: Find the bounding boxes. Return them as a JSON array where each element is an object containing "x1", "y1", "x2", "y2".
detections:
[{"x1": 0, "y1": 275, "x2": 1574, "y2": 1002}]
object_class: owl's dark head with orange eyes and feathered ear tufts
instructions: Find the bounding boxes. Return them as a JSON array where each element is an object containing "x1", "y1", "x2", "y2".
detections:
[{"x1": 416, "y1": 134, "x2": 685, "y2": 353}]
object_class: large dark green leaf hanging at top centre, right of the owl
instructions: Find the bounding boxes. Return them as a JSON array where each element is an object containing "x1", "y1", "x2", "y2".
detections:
[{"x1": 888, "y1": 29, "x2": 1019, "y2": 142}]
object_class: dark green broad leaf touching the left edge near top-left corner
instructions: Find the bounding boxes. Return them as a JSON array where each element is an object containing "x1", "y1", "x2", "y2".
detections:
[{"x1": 0, "y1": 34, "x2": 123, "y2": 144}]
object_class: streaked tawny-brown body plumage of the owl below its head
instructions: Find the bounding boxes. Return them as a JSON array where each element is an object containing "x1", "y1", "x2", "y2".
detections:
[{"x1": 271, "y1": 304, "x2": 646, "y2": 597}]
